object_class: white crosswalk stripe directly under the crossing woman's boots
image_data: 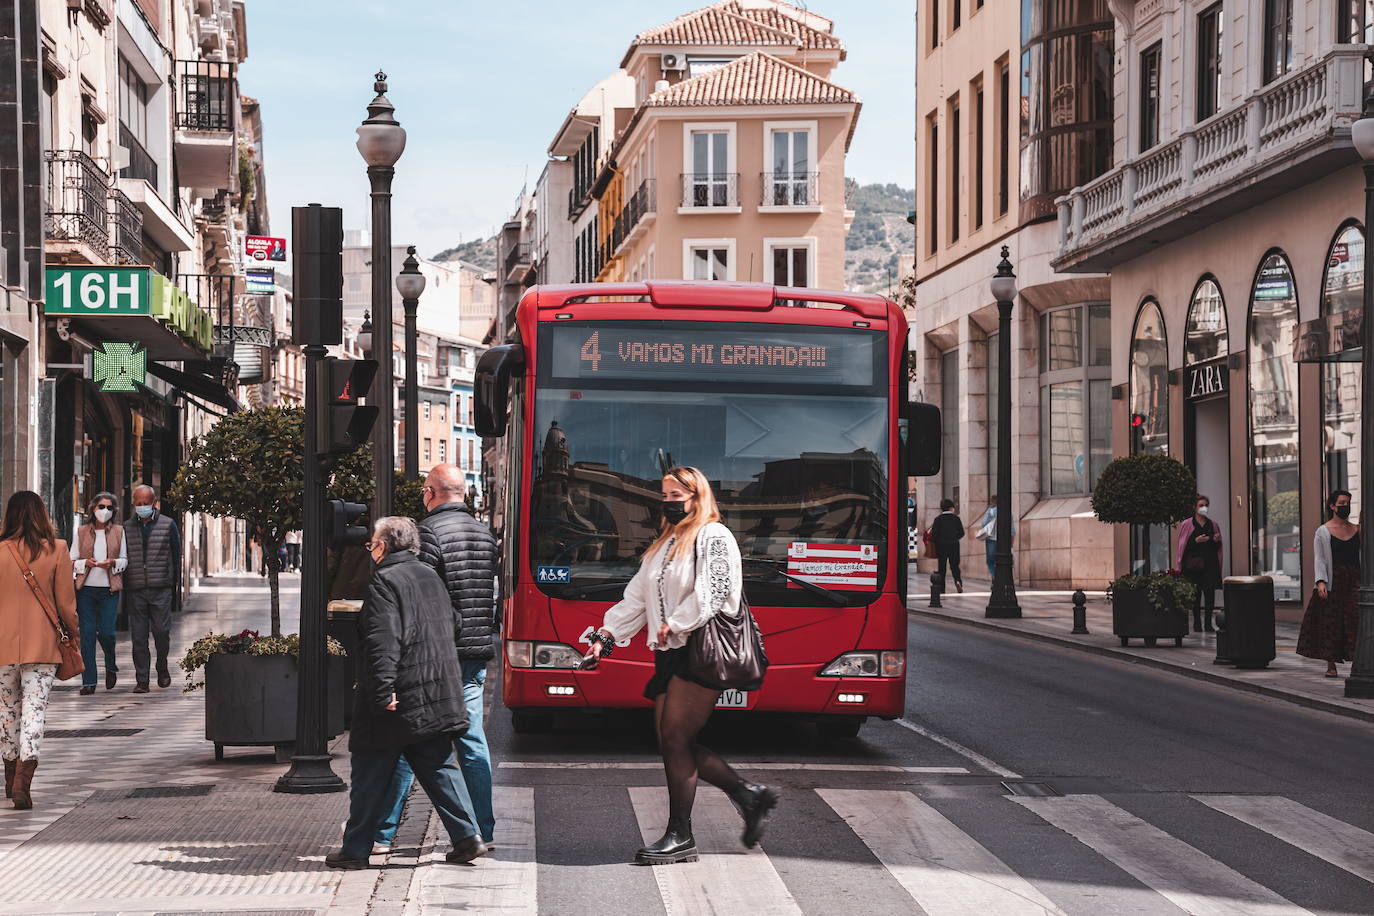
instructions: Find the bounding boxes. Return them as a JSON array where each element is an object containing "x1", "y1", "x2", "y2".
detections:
[{"x1": 629, "y1": 787, "x2": 801, "y2": 916}]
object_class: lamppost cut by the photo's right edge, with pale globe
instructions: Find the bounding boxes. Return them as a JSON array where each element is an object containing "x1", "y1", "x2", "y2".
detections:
[{"x1": 1345, "y1": 109, "x2": 1374, "y2": 699}]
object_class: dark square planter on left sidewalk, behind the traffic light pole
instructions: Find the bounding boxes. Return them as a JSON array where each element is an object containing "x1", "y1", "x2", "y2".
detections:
[{"x1": 205, "y1": 654, "x2": 348, "y2": 762}]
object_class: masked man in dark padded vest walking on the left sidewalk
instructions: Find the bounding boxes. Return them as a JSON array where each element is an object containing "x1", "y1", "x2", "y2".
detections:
[{"x1": 124, "y1": 483, "x2": 181, "y2": 694}]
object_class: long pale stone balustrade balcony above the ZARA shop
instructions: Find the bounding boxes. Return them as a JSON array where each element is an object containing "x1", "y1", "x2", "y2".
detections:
[{"x1": 1054, "y1": 45, "x2": 1366, "y2": 271}]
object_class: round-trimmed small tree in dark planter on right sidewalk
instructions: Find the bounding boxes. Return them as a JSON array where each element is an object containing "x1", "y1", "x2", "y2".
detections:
[{"x1": 1092, "y1": 455, "x2": 1197, "y2": 645}]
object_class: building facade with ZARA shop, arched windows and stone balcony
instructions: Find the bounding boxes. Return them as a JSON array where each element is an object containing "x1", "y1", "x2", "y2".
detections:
[{"x1": 1055, "y1": 0, "x2": 1374, "y2": 612}]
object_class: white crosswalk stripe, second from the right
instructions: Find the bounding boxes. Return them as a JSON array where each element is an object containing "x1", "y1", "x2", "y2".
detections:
[{"x1": 1011, "y1": 795, "x2": 1307, "y2": 916}]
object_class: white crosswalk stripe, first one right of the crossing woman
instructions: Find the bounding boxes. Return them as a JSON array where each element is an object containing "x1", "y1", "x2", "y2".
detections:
[{"x1": 816, "y1": 788, "x2": 1062, "y2": 916}]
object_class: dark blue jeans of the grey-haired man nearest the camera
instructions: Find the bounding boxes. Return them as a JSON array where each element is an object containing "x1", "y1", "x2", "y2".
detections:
[{"x1": 344, "y1": 735, "x2": 477, "y2": 858}]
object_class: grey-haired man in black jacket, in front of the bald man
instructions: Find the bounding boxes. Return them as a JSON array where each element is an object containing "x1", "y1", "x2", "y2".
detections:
[{"x1": 324, "y1": 516, "x2": 486, "y2": 868}]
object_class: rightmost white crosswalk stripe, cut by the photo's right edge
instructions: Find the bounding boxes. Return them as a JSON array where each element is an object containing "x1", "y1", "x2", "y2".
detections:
[{"x1": 1193, "y1": 795, "x2": 1374, "y2": 883}]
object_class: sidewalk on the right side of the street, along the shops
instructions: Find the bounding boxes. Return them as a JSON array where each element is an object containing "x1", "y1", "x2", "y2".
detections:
[{"x1": 908, "y1": 574, "x2": 1374, "y2": 721}]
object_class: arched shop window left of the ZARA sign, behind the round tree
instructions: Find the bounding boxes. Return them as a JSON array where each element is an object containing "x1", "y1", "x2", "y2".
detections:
[{"x1": 1128, "y1": 299, "x2": 1172, "y2": 570}]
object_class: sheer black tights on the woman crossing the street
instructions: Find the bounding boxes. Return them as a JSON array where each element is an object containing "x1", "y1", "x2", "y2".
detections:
[{"x1": 654, "y1": 677, "x2": 743, "y2": 821}]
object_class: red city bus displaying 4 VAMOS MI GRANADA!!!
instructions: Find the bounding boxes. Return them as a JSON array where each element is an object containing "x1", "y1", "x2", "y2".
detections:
[{"x1": 475, "y1": 282, "x2": 940, "y2": 735}]
